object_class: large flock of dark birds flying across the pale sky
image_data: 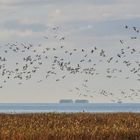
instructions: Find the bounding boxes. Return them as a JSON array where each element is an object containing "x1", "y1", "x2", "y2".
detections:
[{"x1": 0, "y1": 25, "x2": 140, "y2": 102}]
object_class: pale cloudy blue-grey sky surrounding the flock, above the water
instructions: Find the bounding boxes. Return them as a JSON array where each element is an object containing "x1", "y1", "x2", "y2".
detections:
[{"x1": 0, "y1": 0, "x2": 140, "y2": 103}]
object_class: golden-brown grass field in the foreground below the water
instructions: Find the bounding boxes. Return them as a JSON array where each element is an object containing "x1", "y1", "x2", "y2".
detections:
[{"x1": 0, "y1": 113, "x2": 140, "y2": 140}]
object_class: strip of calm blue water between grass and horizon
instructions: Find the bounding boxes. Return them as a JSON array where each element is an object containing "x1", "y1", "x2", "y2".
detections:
[{"x1": 0, "y1": 103, "x2": 140, "y2": 113}]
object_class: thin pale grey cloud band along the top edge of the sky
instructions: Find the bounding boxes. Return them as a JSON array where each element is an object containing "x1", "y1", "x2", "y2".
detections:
[{"x1": 0, "y1": 0, "x2": 122, "y2": 6}]
